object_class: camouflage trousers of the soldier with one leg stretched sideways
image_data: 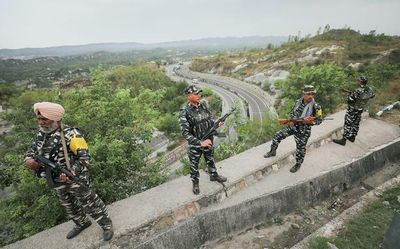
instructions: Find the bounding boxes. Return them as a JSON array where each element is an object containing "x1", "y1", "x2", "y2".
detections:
[{"x1": 271, "y1": 126, "x2": 311, "y2": 165}]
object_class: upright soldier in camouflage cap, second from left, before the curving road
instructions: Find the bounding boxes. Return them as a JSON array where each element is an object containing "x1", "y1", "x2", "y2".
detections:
[{"x1": 179, "y1": 85, "x2": 226, "y2": 195}]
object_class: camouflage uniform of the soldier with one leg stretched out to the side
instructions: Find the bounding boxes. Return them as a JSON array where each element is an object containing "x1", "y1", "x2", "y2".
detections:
[{"x1": 271, "y1": 98, "x2": 322, "y2": 165}]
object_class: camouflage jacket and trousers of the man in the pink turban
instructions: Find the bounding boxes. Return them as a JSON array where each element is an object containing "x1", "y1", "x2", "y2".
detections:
[{"x1": 26, "y1": 127, "x2": 112, "y2": 230}]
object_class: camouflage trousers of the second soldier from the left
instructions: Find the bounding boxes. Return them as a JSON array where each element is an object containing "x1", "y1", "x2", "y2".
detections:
[{"x1": 188, "y1": 146, "x2": 217, "y2": 181}]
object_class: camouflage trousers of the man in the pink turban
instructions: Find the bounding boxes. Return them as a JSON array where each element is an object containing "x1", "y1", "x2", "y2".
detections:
[{"x1": 55, "y1": 177, "x2": 112, "y2": 230}]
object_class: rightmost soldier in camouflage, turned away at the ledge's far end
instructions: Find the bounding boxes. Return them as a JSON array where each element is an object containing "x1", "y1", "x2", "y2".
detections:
[{"x1": 333, "y1": 76, "x2": 375, "y2": 146}]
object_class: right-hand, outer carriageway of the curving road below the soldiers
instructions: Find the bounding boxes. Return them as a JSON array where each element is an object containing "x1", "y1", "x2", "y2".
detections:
[{"x1": 175, "y1": 65, "x2": 276, "y2": 120}]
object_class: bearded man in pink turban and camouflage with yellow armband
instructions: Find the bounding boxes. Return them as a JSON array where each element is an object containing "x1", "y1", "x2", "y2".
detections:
[{"x1": 25, "y1": 102, "x2": 114, "y2": 241}]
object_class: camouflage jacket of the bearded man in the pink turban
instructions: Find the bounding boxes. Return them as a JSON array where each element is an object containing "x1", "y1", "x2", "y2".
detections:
[{"x1": 25, "y1": 127, "x2": 90, "y2": 187}]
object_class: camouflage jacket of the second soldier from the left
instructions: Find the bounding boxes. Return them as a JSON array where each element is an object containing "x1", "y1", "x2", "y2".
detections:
[{"x1": 179, "y1": 103, "x2": 214, "y2": 146}]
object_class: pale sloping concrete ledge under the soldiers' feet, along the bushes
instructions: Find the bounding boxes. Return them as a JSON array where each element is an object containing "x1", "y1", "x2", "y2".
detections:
[{"x1": 2, "y1": 111, "x2": 378, "y2": 249}]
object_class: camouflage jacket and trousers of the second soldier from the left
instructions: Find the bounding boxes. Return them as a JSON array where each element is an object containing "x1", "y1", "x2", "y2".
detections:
[{"x1": 179, "y1": 103, "x2": 217, "y2": 181}]
